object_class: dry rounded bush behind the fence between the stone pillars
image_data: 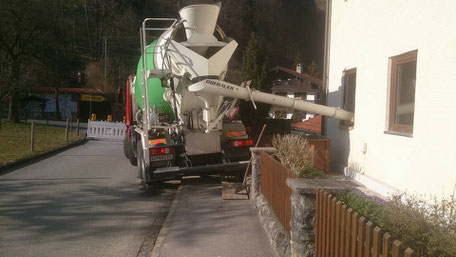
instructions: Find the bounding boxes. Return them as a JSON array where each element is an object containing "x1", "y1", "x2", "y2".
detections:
[{"x1": 272, "y1": 134, "x2": 315, "y2": 178}]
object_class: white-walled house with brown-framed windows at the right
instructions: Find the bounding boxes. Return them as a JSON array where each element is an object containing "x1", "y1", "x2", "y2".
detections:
[{"x1": 326, "y1": 0, "x2": 456, "y2": 197}]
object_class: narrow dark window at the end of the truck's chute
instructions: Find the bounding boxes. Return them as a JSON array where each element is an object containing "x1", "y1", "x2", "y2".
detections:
[{"x1": 339, "y1": 68, "x2": 356, "y2": 128}]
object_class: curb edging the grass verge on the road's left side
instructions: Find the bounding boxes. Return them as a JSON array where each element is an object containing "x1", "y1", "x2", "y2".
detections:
[{"x1": 0, "y1": 138, "x2": 88, "y2": 176}]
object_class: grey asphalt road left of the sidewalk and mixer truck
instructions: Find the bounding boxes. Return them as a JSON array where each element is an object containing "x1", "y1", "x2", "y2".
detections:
[{"x1": 0, "y1": 141, "x2": 177, "y2": 257}]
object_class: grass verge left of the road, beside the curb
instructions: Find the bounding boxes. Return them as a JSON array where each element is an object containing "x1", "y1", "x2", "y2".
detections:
[{"x1": 0, "y1": 122, "x2": 83, "y2": 167}]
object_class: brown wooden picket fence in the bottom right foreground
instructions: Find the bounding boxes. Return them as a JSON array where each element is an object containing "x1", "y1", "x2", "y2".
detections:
[{"x1": 315, "y1": 189, "x2": 415, "y2": 257}]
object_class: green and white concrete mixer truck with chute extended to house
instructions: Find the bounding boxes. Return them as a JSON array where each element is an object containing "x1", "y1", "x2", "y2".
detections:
[{"x1": 126, "y1": 4, "x2": 353, "y2": 186}]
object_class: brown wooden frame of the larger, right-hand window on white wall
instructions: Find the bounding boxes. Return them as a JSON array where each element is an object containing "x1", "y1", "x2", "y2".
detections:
[{"x1": 388, "y1": 50, "x2": 418, "y2": 136}]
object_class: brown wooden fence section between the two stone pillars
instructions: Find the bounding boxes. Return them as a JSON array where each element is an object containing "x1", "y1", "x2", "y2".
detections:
[{"x1": 261, "y1": 152, "x2": 294, "y2": 233}]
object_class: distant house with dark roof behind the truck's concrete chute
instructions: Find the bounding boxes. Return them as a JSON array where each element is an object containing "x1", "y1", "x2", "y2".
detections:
[{"x1": 270, "y1": 64, "x2": 323, "y2": 119}]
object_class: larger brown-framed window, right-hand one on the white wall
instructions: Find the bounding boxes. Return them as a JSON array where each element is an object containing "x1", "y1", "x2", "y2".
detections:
[{"x1": 388, "y1": 51, "x2": 417, "y2": 135}]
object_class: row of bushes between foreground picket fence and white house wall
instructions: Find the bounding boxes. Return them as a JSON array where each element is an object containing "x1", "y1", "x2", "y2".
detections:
[{"x1": 338, "y1": 189, "x2": 456, "y2": 257}]
